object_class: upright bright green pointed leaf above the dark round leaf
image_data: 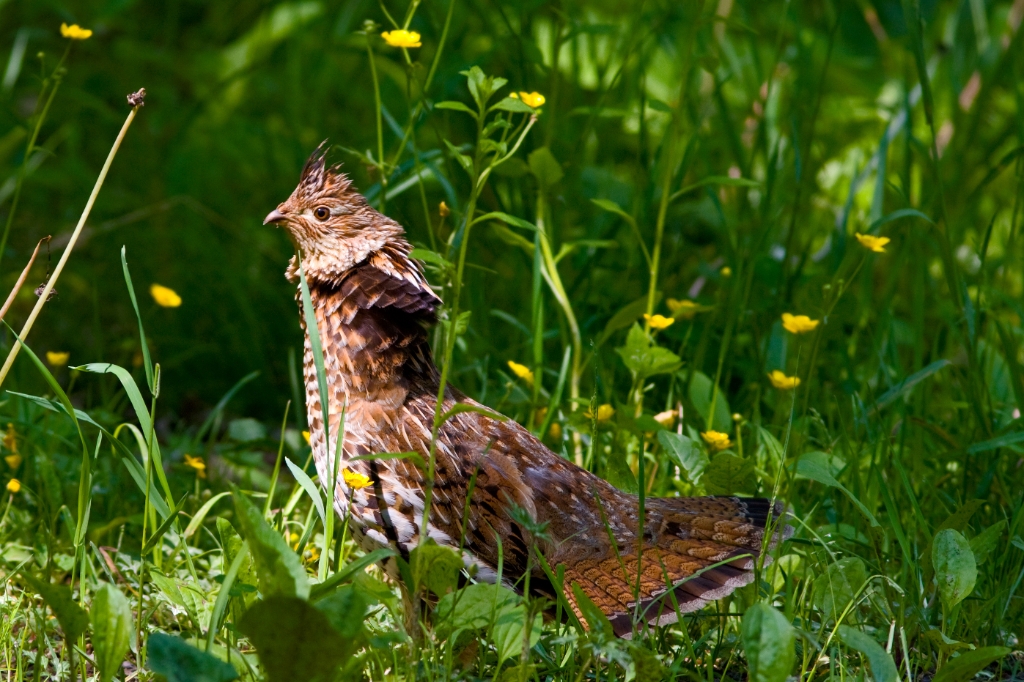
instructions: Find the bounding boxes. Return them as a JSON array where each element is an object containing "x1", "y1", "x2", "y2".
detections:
[{"x1": 232, "y1": 489, "x2": 309, "y2": 599}]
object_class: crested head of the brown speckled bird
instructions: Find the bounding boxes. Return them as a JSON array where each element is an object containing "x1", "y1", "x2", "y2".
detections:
[{"x1": 263, "y1": 141, "x2": 403, "y2": 278}]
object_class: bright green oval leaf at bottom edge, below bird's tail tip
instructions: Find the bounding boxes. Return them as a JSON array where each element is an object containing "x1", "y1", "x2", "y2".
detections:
[{"x1": 741, "y1": 603, "x2": 797, "y2": 682}]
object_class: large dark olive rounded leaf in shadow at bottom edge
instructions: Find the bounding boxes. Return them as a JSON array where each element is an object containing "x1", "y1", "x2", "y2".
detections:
[{"x1": 239, "y1": 596, "x2": 350, "y2": 682}]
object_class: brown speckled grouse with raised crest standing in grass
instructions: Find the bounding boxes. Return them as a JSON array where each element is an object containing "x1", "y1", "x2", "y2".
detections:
[{"x1": 263, "y1": 141, "x2": 792, "y2": 638}]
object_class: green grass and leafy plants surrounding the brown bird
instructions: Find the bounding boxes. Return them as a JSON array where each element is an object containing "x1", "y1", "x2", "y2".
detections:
[{"x1": 0, "y1": 0, "x2": 1024, "y2": 682}]
